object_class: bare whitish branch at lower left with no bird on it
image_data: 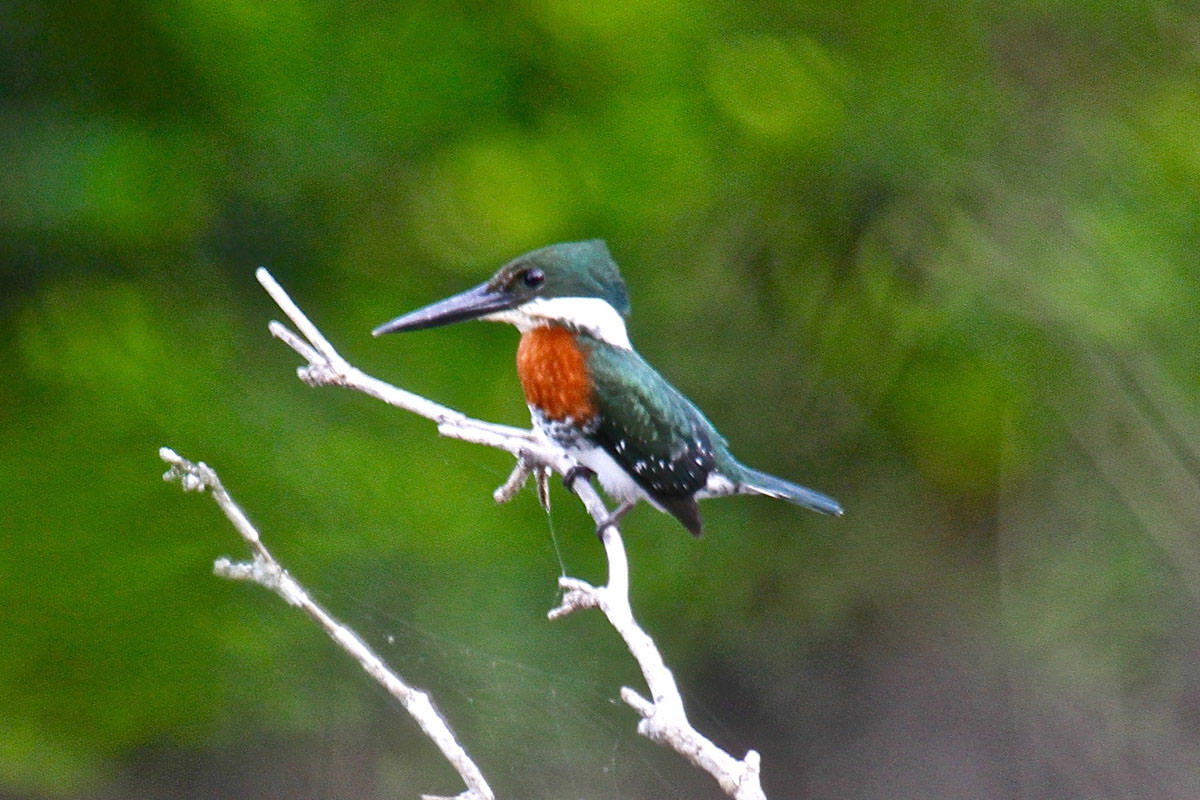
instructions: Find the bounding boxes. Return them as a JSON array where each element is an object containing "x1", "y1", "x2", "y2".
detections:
[{"x1": 158, "y1": 448, "x2": 496, "y2": 800}]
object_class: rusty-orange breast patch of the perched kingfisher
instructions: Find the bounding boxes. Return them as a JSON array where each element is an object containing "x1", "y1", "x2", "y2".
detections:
[{"x1": 517, "y1": 325, "x2": 596, "y2": 423}]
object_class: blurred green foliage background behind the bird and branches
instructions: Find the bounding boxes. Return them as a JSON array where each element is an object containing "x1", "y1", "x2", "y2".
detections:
[{"x1": 0, "y1": 0, "x2": 1200, "y2": 799}]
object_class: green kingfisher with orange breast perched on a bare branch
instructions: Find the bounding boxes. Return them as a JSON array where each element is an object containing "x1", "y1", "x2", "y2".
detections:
[{"x1": 372, "y1": 239, "x2": 841, "y2": 536}]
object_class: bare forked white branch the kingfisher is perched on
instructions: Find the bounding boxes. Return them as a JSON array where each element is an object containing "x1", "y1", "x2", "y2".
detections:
[{"x1": 246, "y1": 269, "x2": 766, "y2": 800}]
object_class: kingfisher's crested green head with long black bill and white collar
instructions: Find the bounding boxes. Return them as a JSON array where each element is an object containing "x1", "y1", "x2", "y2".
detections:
[{"x1": 372, "y1": 239, "x2": 629, "y2": 349}]
